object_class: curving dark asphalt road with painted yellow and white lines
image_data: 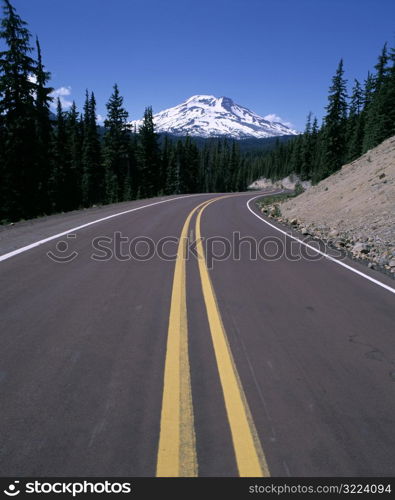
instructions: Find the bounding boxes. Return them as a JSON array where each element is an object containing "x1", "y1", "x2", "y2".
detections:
[{"x1": 0, "y1": 193, "x2": 395, "y2": 477}]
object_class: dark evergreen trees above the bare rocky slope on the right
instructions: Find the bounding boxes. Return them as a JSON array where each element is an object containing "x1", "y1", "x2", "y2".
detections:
[{"x1": 250, "y1": 44, "x2": 395, "y2": 183}]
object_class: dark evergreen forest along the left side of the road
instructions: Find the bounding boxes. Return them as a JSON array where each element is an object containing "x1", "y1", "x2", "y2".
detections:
[{"x1": 0, "y1": 0, "x2": 254, "y2": 222}]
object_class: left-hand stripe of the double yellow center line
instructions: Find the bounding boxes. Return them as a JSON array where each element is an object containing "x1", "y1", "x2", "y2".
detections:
[{"x1": 156, "y1": 198, "x2": 224, "y2": 477}]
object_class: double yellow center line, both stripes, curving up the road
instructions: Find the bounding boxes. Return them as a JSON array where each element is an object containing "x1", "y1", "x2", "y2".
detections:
[{"x1": 156, "y1": 197, "x2": 269, "y2": 477}]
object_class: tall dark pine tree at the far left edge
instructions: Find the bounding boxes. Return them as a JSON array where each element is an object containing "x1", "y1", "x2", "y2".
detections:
[{"x1": 0, "y1": 0, "x2": 39, "y2": 220}]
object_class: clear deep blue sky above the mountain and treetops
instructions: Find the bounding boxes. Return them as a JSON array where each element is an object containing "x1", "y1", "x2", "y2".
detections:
[{"x1": 6, "y1": 0, "x2": 395, "y2": 129}]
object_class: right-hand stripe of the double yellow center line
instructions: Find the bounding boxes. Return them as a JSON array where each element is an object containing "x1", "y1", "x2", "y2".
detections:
[{"x1": 196, "y1": 200, "x2": 270, "y2": 477}]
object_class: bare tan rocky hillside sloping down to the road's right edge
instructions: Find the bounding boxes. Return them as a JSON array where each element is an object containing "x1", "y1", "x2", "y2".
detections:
[{"x1": 265, "y1": 136, "x2": 395, "y2": 274}]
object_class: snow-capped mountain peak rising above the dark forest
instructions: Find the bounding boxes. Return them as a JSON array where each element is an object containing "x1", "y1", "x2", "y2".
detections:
[{"x1": 129, "y1": 95, "x2": 298, "y2": 139}]
